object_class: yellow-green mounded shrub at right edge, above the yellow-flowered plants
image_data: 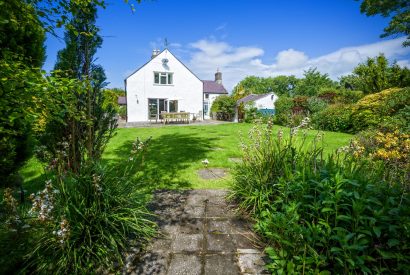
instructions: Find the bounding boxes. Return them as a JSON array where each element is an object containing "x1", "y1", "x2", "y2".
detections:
[{"x1": 351, "y1": 88, "x2": 410, "y2": 131}]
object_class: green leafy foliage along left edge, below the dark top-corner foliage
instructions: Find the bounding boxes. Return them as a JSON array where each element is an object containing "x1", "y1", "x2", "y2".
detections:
[{"x1": 0, "y1": 55, "x2": 41, "y2": 185}]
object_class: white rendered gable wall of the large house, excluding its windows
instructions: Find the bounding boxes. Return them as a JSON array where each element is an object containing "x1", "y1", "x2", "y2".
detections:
[{"x1": 126, "y1": 50, "x2": 203, "y2": 122}]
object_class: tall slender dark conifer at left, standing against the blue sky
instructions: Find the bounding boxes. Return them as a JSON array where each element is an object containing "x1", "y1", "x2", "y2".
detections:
[{"x1": 43, "y1": 2, "x2": 116, "y2": 171}]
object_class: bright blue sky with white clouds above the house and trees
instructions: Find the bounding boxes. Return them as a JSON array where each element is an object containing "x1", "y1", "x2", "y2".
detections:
[{"x1": 44, "y1": 0, "x2": 410, "y2": 90}]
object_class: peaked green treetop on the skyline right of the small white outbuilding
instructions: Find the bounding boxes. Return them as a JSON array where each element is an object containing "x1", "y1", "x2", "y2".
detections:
[{"x1": 295, "y1": 68, "x2": 335, "y2": 96}]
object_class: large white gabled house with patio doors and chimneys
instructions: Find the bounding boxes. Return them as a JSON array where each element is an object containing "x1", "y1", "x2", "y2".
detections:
[{"x1": 124, "y1": 49, "x2": 227, "y2": 122}]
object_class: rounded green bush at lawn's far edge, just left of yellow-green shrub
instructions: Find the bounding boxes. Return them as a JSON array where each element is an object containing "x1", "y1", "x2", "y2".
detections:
[{"x1": 312, "y1": 104, "x2": 352, "y2": 132}]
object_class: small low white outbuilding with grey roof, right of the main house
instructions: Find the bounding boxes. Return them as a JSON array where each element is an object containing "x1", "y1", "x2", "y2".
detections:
[{"x1": 235, "y1": 93, "x2": 279, "y2": 121}]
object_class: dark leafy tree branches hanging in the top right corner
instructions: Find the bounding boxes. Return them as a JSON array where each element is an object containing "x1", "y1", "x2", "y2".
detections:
[{"x1": 356, "y1": 0, "x2": 410, "y2": 47}]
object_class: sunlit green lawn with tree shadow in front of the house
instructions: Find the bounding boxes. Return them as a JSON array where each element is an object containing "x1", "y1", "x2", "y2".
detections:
[{"x1": 103, "y1": 123, "x2": 352, "y2": 189}]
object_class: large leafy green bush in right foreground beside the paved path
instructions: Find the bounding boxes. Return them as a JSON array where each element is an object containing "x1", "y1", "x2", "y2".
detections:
[{"x1": 231, "y1": 125, "x2": 410, "y2": 274}]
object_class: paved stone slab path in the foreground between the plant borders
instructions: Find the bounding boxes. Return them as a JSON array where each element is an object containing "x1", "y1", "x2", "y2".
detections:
[{"x1": 127, "y1": 190, "x2": 266, "y2": 275}]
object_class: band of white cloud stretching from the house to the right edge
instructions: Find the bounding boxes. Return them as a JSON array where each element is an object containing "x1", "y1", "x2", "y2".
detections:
[{"x1": 187, "y1": 37, "x2": 410, "y2": 90}]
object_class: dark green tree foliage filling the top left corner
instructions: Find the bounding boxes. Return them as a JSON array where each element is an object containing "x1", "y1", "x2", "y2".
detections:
[{"x1": 0, "y1": 0, "x2": 45, "y2": 67}]
